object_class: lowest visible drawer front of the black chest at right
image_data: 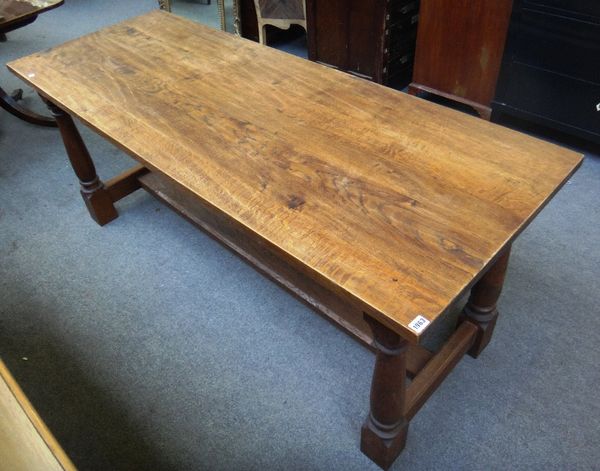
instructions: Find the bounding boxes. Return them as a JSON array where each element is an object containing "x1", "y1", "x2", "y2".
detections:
[{"x1": 500, "y1": 63, "x2": 600, "y2": 136}]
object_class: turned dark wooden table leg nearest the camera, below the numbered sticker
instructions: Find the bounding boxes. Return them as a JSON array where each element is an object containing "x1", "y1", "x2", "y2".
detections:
[{"x1": 360, "y1": 315, "x2": 408, "y2": 469}]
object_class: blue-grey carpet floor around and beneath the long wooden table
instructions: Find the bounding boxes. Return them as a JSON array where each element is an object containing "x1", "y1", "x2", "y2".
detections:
[{"x1": 0, "y1": 0, "x2": 600, "y2": 470}]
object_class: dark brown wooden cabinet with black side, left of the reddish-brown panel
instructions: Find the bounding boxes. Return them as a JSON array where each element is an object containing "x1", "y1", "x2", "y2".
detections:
[{"x1": 306, "y1": 0, "x2": 419, "y2": 87}]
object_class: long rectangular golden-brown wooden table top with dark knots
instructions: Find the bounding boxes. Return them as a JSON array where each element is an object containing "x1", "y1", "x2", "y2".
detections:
[{"x1": 8, "y1": 11, "x2": 582, "y2": 342}]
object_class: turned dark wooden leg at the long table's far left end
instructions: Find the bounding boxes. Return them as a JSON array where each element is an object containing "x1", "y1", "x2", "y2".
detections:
[{"x1": 44, "y1": 99, "x2": 118, "y2": 226}]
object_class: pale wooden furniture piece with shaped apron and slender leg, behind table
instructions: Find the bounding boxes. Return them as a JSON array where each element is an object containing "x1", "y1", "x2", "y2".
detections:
[{"x1": 254, "y1": 0, "x2": 306, "y2": 44}]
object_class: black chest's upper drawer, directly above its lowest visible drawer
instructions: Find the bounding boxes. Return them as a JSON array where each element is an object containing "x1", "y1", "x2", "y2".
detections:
[{"x1": 513, "y1": 9, "x2": 600, "y2": 84}]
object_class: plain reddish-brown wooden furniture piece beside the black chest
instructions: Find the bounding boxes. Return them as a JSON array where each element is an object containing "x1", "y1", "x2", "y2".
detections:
[{"x1": 409, "y1": 0, "x2": 512, "y2": 119}]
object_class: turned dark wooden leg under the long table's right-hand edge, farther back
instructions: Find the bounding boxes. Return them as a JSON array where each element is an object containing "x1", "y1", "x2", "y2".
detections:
[{"x1": 461, "y1": 247, "x2": 510, "y2": 358}]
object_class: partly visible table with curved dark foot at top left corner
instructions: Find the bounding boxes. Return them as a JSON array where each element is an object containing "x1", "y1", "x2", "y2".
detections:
[{"x1": 0, "y1": 0, "x2": 64, "y2": 127}]
